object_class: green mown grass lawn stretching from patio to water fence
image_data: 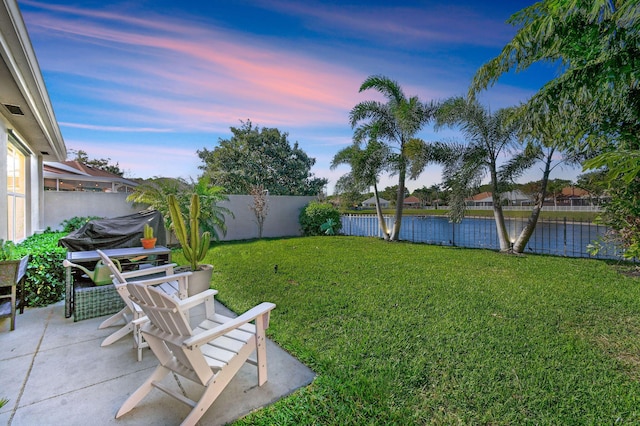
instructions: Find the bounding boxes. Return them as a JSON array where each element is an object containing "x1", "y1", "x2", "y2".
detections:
[{"x1": 176, "y1": 237, "x2": 640, "y2": 425}]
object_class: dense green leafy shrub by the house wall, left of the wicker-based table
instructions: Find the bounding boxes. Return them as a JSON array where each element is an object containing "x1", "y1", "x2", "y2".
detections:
[{"x1": 16, "y1": 232, "x2": 67, "y2": 306}]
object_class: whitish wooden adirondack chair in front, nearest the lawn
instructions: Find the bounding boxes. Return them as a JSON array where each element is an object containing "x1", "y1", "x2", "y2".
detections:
[{"x1": 116, "y1": 282, "x2": 276, "y2": 425}]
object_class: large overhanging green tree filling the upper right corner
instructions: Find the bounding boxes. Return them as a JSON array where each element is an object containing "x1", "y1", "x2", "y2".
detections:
[{"x1": 470, "y1": 0, "x2": 640, "y2": 256}]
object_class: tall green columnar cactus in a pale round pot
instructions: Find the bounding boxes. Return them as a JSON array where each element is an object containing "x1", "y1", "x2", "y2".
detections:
[{"x1": 167, "y1": 194, "x2": 213, "y2": 296}]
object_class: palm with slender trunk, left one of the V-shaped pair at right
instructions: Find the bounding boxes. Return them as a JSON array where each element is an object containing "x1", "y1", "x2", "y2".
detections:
[{"x1": 432, "y1": 97, "x2": 530, "y2": 251}]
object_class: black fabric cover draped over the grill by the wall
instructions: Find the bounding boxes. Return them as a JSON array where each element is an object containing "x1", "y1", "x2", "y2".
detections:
[{"x1": 58, "y1": 210, "x2": 167, "y2": 251}]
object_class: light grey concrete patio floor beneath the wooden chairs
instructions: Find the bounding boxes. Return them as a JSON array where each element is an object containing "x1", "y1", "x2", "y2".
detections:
[{"x1": 0, "y1": 302, "x2": 315, "y2": 426}]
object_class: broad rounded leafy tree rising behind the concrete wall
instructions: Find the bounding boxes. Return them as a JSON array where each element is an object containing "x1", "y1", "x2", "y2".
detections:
[{"x1": 198, "y1": 120, "x2": 327, "y2": 195}]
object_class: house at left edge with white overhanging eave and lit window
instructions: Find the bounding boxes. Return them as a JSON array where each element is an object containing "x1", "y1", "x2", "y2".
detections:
[{"x1": 0, "y1": 0, "x2": 67, "y2": 242}]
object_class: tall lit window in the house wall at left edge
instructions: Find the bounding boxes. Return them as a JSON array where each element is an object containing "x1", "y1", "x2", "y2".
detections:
[{"x1": 7, "y1": 141, "x2": 27, "y2": 241}]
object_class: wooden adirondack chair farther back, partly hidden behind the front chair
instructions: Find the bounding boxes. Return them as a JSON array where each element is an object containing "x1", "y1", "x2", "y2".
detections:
[{"x1": 96, "y1": 250, "x2": 191, "y2": 361}]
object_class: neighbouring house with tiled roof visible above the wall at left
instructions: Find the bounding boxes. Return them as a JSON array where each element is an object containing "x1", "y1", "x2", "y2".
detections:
[{"x1": 43, "y1": 161, "x2": 138, "y2": 193}]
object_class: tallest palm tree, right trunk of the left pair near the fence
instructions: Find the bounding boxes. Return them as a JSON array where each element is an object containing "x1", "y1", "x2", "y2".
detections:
[{"x1": 349, "y1": 75, "x2": 433, "y2": 241}]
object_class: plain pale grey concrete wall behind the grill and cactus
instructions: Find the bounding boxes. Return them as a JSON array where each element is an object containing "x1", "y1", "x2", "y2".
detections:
[{"x1": 44, "y1": 191, "x2": 316, "y2": 241}]
